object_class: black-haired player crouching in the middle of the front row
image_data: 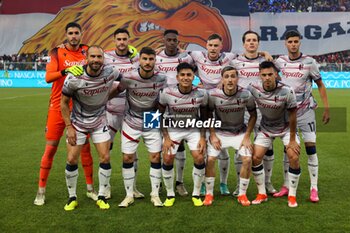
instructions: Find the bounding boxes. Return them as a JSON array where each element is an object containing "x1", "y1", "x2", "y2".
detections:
[{"x1": 159, "y1": 63, "x2": 208, "y2": 207}]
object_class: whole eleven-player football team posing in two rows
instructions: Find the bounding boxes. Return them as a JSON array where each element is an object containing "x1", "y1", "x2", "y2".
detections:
[{"x1": 34, "y1": 22, "x2": 330, "y2": 211}]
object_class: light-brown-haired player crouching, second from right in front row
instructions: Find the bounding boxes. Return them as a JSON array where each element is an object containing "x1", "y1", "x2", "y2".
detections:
[{"x1": 203, "y1": 66, "x2": 257, "y2": 206}]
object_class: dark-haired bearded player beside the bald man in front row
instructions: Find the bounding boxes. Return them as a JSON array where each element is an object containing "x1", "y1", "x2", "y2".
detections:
[{"x1": 113, "y1": 47, "x2": 166, "y2": 208}]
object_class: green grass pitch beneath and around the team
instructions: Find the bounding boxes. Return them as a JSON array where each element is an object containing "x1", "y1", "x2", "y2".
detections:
[{"x1": 0, "y1": 89, "x2": 350, "y2": 233}]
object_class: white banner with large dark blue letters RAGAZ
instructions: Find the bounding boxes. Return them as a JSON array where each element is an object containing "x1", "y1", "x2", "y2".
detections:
[{"x1": 251, "y1": 12, "x2": 350, "y2": 55}]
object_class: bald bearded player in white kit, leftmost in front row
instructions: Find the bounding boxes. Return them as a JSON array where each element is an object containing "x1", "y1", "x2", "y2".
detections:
[{"x1": 61, "y1": 45, "x2": 119, "y2": 211}]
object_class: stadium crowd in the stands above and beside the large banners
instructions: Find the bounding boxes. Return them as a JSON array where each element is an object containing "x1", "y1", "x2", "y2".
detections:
[{"x1": 0, "y1": 0, "x2": 350, "y2": 71}]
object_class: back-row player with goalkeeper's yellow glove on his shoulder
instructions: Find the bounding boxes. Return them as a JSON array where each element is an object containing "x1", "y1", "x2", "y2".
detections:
[{"x1": 104, "y1": 28, "x2": 145, "y2": 199}]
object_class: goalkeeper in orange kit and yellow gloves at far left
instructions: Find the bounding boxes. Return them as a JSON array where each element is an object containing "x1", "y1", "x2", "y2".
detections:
[{"x1": 34, "y1": 22, "x2": 97, "y2": 205}]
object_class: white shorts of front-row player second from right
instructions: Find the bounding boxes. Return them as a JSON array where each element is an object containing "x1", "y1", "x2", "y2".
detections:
[{"x1": 208, "y1": 132, "x2": 252, "y2": 157}]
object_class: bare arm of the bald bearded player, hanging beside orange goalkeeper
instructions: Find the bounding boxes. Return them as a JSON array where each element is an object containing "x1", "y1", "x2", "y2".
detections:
[{"x1": 61, "y1": 94, "x2": 77, "y2": 146}]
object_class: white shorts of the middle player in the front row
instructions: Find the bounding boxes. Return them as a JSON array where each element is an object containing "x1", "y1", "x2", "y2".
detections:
[{"x1": 168, "y1": 129, "x2": 201, "y2": 155}]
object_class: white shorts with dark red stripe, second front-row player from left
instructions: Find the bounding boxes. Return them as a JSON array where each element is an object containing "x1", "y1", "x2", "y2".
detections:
[{"x1": 122, "y1": 121, "x2": 162, "y2": 154}]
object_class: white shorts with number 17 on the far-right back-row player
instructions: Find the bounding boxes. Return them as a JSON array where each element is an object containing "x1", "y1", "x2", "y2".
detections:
[{"x1": 297, "y1": 109, "x2": 316, "y2": 143}]
